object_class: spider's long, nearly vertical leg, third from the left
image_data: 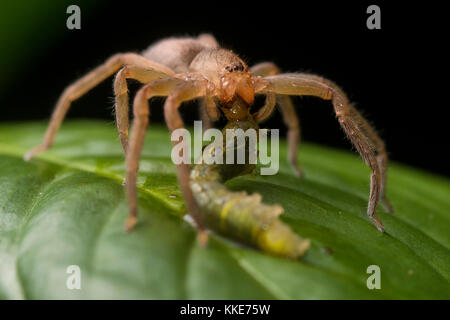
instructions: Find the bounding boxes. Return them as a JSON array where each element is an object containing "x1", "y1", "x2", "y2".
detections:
[{"x1": 125, "y1": 78, "x2": 180, "y2": 231}]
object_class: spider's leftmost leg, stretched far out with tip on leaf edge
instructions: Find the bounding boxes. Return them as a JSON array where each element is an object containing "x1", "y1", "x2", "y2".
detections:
[{"x1": 24, "y1": 53, "x2": 173, "y2": 161}]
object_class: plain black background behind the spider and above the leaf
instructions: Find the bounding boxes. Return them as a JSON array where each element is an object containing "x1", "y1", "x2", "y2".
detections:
[{"x1": 0, "y1": 1, "x2": 450, "y2": 175}]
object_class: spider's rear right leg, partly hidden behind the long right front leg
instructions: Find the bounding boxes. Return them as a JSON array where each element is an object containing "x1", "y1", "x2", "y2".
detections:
[{"x1": 251, "y1": 62, "x2": 303, "y2": 177}]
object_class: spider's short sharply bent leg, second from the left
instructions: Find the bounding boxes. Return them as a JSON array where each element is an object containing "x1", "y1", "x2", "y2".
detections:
[{"x1": 114, "y1": 65, "x2": 169, "y2": 155}]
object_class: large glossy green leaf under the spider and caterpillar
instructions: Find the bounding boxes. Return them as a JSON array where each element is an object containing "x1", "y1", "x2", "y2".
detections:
[{"x1": 0, "y1": 121, "x2": 450, "y2": 299}]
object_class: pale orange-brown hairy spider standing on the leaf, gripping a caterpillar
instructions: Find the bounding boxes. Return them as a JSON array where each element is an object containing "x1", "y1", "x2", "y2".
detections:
[{"x1": 24, "y1": 34, "x2": 392, "y2": 239}]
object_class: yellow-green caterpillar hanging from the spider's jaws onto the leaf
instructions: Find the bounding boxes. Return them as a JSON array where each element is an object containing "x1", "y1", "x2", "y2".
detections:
[{"x1": 190, "y1": 116, "x2": 310, "y2": 259}]
